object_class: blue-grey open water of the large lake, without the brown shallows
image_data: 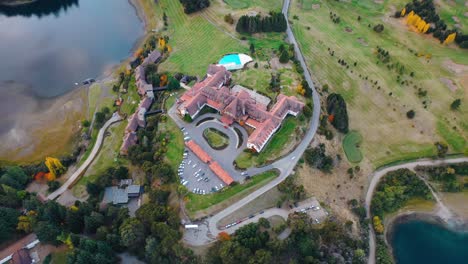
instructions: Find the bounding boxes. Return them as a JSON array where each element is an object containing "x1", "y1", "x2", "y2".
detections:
[{"x1": 0, "y1": 0, "x2": 143, "y2": 98}]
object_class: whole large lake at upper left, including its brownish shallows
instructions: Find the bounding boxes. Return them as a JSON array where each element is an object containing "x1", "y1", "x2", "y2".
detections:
[{"x1": 0, "y1": 0, "x2": 144, "y2": 162}]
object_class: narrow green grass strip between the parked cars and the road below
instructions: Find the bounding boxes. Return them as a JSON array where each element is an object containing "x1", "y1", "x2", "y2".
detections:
[{"x1": 186, "y1": 171, "x2": 278, "y2": 213}]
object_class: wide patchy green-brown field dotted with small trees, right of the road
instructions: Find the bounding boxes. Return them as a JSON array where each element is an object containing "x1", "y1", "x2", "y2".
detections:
[{"x1": 290, "y1": 0, "x2": 468, "y2": 167}]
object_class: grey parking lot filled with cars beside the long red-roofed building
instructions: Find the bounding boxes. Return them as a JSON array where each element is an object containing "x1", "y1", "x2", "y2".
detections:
[{"x1": 178, "y1": 149, "x2": 225, "y2": 195}]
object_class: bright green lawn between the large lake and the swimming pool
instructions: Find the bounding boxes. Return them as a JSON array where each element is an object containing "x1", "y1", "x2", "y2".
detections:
[{"x1": 159, "y1": 0, "x2": 248, "y2": 77}]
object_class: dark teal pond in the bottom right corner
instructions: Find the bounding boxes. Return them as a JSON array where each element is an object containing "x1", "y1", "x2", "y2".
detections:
[{"x1": 391, "y1": 220, "x2": 468, "y2": 264}]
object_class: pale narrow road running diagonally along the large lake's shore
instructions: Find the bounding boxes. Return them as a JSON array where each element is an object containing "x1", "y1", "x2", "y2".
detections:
[{"x1": 47, "y1": 112, "x2": 122, "y2": 200}]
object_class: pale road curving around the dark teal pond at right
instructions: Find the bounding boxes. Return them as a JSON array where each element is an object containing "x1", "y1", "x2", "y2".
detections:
[{"x1": 365, "y1": 157, "x2": 468, "y2": 264}]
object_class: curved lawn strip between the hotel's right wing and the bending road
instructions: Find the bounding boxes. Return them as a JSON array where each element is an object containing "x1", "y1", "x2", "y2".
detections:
[{"x1": 236, "y1": 116, "x2": 299, "y2": 169}]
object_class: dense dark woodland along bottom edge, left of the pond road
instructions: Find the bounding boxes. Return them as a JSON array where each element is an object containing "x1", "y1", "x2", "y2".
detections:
[{"x1": 206, "y1": 213, "x2": 367, "y2": 264}]
